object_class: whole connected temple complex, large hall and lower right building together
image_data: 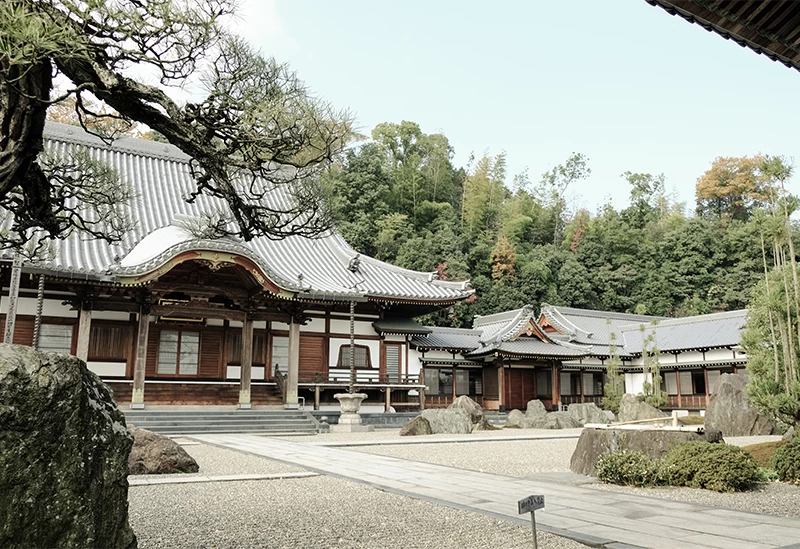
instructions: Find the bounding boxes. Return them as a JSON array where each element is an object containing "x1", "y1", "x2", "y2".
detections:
[{"x1": 0, "y1": 123, "x2": 747, "y2": 411}]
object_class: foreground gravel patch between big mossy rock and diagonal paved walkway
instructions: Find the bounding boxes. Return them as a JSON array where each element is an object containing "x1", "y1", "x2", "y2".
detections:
[{"x1": 129, "y1": 474, "x2": 585, "y2": 549}]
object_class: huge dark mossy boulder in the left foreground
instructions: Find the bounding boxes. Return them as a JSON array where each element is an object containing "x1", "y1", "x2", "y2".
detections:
[{"x1": 0, "y1": 344, "x2": 136, "y2": 549}]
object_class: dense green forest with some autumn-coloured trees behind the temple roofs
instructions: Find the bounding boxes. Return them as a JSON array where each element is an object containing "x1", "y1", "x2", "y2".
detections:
[{"x1": 324, "y1": 122, "x2": 792, "y2": 326}]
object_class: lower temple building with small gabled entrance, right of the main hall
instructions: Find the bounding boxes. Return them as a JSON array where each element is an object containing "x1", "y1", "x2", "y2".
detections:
[{"x1": 411, "y1": 303, "x2": 747, "y2": 411}]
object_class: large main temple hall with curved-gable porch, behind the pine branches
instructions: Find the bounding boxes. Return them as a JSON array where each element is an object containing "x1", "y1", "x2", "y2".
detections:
[{"x1": 0, "y1": 123, "x2": 473, "y2": 408}]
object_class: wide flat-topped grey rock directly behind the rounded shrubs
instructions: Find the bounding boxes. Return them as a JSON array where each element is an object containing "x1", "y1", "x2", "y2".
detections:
[{"x1": 569, "y1": 429, "x2": 718, "y2": 476}]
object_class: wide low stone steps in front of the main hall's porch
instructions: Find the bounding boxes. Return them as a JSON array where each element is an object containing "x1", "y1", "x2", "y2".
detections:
[{"x1": 123, "y1": 409, "x2": 317, "y2": 435}]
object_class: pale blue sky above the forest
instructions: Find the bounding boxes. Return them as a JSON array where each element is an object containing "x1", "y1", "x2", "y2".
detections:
[{"x1": 237, "y1": 0, "x2": 800, "y2": 212}]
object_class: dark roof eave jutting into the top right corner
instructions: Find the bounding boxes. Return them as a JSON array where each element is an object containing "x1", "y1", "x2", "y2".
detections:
[{"x1": 645, "y1": 0, "x2": 800, "y2": 70}]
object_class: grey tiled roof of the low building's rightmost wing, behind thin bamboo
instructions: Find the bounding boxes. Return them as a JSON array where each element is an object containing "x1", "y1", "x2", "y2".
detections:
[{"x1": 623, "y1": 309, "x2": 747, "y2": 353}]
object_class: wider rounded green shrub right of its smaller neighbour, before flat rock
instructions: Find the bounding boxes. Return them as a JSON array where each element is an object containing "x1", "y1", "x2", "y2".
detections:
[{"x1": 659, "y1": 442, "x2": 759, "y2": 492}]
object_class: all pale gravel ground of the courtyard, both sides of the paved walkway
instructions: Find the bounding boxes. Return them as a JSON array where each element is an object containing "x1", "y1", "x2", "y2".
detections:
[{"x1": 129, "y1": 430, "x2": 800, "y2": 549}]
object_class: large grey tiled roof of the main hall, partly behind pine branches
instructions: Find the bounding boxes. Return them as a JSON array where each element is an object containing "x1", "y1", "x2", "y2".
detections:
[{"x1": 0, "y1": 123, "x2": 472, "y2": 302}]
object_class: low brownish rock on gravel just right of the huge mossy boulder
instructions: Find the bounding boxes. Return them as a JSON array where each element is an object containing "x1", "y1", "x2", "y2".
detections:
[{"x1": 128, "y1": 427, "x2": 200, "y2": 475}]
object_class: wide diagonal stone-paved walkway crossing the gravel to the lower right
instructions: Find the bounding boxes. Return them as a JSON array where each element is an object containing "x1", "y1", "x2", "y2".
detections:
[{"x1": 192, "y1": 435, "x2": 800, "y2": 549}]
